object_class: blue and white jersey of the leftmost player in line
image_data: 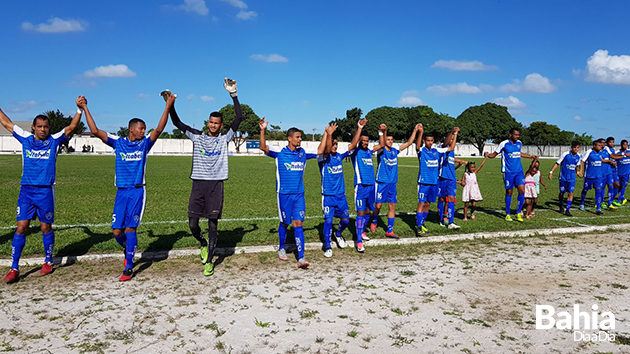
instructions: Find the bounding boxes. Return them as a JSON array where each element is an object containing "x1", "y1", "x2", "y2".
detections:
[{"x1": 13, "y1": 125, "x2": 68, "y2": 186}]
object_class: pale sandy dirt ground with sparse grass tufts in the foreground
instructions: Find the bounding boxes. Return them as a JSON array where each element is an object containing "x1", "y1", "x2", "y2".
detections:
[{"x1": 0, "y1": 234, "x2": 630, "y2": 353}]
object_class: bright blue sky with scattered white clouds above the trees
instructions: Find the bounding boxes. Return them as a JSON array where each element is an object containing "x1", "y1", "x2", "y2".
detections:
[{"x1": 0, "y1": 0, "x2": 630, "y2": 141}]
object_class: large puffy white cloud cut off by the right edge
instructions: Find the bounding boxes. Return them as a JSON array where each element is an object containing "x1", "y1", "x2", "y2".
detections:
[{"x1": 584, "y1": 49, "x2": 630, "y2": 85}]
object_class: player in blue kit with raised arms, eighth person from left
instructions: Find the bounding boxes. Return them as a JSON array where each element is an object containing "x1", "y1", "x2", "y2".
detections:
[{"x1": 416, "y1": 124, "x2": 459, "y2": 236}]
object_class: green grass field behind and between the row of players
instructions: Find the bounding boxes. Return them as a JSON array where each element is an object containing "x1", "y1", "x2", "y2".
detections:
[{"x1": 0, "y1": 155, "x2": 630, "y2": 258}]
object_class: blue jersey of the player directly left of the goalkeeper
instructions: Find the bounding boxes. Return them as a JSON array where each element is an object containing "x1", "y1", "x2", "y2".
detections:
[{"x1": 105, "y1": 134, "x2": 155, "y2": 188}]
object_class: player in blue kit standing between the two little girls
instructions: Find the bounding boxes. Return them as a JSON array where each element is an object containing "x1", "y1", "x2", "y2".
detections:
[{"x1": 484, "y1": 128, "x2": 538, "y2": 222}]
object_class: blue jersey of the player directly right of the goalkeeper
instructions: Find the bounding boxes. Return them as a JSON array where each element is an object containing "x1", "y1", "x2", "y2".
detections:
[{"x1": 267, "y1": 146, "x2": 317, "y2": 194}]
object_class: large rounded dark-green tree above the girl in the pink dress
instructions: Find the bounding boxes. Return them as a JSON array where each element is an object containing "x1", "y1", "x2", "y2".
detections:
[{"x1": 456, "y1": 102, "x2": 522, "y2": 155}]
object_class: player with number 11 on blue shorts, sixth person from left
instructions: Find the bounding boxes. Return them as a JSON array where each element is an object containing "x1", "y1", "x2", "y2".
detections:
[{"x1": 348, "y1": 118, "x2": 376, "y2": 253}]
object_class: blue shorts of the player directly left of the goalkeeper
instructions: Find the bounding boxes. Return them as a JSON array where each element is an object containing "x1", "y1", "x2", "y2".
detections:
[{"x1": 112, "y1": 187, "x2": 147, "y2": 229}]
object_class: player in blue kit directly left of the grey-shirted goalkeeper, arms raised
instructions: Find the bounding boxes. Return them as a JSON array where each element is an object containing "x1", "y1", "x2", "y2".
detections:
[{"x1": 80, "y1": 94, "x2": 177, "y2": 281}]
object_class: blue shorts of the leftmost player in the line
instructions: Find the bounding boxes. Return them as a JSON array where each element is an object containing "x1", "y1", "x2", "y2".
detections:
[{"x1": 17, "y1": 186, "x2": 55, "y2": 224}]
